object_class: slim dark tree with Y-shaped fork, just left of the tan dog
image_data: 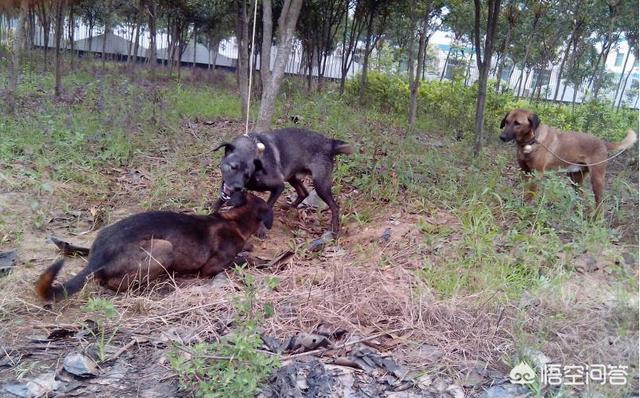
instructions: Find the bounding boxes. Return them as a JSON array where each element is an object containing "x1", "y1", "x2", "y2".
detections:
[{"x1": 473, "y1": 0, "x2": 501, "y2": 155}]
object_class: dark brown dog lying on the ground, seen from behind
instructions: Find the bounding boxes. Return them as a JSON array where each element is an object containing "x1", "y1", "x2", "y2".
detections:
[{"x1": 36, "y1": 194, "x2": 273, "y2": 301}]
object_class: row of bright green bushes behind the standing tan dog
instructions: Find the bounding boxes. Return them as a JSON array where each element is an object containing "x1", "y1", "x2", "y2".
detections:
[{"x1": 346, "y1": 72, "x2": 638, "y2": 141}]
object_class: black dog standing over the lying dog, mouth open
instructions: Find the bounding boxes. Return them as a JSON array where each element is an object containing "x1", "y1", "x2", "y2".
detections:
[{"x1": 214, "y1": 128, "x2": 352, "y2": 234}]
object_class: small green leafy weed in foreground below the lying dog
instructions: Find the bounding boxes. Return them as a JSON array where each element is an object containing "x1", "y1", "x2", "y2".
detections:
[{"x1": 169, "y1": 269, "x2": 279, "y2": 398}]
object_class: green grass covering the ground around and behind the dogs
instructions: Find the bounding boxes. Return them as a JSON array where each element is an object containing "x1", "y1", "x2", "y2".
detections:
[{"x1": 0, "y1": 57, "x2": 638, "y2": 391}]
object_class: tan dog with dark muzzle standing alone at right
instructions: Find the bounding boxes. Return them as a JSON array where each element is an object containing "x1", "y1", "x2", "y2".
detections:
[{"x1": 500, "y1": 109, "x2": 636, "y2": 208}]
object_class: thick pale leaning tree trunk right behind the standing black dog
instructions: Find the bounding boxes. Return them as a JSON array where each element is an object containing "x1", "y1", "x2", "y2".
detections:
[{"x1": 257, "y1": 0, "x2": 302, "y2": 131}]
